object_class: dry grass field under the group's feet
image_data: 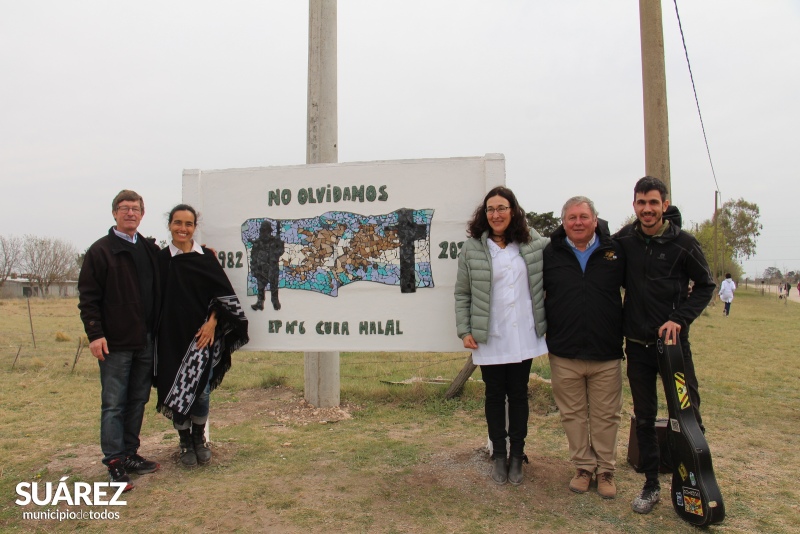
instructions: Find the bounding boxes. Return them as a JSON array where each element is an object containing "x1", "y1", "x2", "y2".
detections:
[{"x1": 0, "y1": 290, "x2": 800, "y2": 533}]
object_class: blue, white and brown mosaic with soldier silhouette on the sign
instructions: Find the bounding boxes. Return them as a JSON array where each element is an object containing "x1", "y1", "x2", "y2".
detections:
[{"x1": 242, "y1": 208, "x2": 434, "y2": 300}]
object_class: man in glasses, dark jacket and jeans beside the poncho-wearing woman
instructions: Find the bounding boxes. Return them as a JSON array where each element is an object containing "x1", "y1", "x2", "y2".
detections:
[{"x1": 78, "y1": 190, "x2": 161, "y2": 491}]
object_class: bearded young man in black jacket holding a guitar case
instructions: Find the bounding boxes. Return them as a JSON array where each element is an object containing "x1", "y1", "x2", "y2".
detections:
[{"x1": 614, "y1": 176, "x2": 716, "y2": 514}]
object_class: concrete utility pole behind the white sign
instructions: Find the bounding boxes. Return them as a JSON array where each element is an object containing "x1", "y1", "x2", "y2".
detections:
[{"x1": 304, "y1": 0, "x2": 341, "y2": 408}]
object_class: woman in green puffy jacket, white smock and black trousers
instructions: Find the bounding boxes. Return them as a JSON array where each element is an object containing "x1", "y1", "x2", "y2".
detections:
[{"x1": 455, "y1": 187, "x2": 547, "y2": 485}]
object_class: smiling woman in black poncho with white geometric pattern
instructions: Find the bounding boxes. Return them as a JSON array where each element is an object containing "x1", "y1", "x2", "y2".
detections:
[{"x1": 156, "y1": 204, "x2": 248, "y2": 466}]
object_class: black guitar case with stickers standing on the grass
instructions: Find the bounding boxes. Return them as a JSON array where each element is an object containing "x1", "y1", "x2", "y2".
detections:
[{"x1": 657, "y1": 338, "x2": 725, "y2": 527}]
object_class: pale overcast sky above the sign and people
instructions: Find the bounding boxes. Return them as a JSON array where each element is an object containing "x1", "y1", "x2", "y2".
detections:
[{"x1": 0, "y1": 0, "x2": 800, "y2": 277}]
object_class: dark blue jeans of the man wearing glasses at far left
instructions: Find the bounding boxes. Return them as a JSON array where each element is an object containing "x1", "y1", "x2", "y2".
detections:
[{"x1": 98, "y1": 335, "x2": 153, "y2": 465}]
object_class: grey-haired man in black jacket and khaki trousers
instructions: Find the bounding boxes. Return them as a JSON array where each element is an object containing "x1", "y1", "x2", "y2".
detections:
[{"x1": 544, "y1": 196, "x2": 625, "y2": 499}]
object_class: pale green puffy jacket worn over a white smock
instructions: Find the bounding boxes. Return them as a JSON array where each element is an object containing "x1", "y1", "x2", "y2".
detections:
[{"x1": 455, "y1": 228, "x2": 550, "y2": 343}]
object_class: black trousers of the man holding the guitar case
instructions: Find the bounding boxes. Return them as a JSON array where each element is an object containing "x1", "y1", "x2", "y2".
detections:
[{"x1": 625, "y1": 338, "x2": 705, "y2": 480}]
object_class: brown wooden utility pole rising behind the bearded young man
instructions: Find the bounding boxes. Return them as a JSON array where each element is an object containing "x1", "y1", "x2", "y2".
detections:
[{"x1": 639, "y1": 0, "x2": 673, "y2": 199}]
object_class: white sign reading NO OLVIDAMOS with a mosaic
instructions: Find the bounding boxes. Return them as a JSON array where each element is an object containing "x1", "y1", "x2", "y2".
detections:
[{"x1": 183, "y1": 154, "x2": 505, "y2": 352}]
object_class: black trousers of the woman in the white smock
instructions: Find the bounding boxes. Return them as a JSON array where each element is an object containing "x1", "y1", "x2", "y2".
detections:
[{"x1": 481, "y1": 360, "x2": 533, "y2": 458}]
